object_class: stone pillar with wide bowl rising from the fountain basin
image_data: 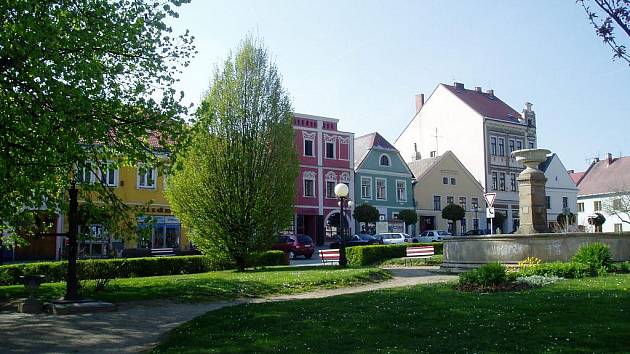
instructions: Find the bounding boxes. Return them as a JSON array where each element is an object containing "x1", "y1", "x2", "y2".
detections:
[{"x1": 512, "y1": 149, "x2": 551, "y2": 235}]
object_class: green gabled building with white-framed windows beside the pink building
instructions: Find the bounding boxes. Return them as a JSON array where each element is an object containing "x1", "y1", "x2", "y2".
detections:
[{"x1": 354, "y1": 133, "x2": 414, "y2": 233}]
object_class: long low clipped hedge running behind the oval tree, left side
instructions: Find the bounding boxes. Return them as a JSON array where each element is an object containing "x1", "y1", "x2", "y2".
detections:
[{"x1": 0, "y1": 251, "x2": 286, "y2": 285}]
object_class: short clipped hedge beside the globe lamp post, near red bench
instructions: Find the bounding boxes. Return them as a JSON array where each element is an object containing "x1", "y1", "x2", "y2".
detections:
[{"x1": 346, "y1": 242, "x2": 442, "y2": 266}]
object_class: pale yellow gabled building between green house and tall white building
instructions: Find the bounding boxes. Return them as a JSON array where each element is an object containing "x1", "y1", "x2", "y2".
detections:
[{"x1": 407, "y1": 151, "x2": 486, "y2": 234}]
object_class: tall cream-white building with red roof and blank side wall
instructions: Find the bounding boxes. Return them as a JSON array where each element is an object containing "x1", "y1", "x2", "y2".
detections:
[{"x1": 394, "y1": 82, "x2": 536, "y2": 232}]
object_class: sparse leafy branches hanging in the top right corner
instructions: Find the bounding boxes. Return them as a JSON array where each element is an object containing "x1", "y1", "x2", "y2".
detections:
[{"x1": 576, "y1": 0, "x2": 630, "y2": 65}]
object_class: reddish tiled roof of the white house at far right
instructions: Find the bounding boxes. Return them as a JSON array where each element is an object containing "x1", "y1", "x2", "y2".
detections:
[{"x1": 578, "y1": 155, "x2": 630, "y2": 196}]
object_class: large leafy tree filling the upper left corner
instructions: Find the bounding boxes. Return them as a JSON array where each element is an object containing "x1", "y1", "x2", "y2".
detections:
[{"x1": 0, "y1": 0, "x2": 194, "y2": 298}]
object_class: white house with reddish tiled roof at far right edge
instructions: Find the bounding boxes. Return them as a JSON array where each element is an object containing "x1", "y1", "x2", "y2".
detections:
[{"x1": 573, "y1": 154, "x2": 630, "y2": 232}]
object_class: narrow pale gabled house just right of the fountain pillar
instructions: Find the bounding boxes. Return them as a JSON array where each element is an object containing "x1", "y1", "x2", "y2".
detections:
[{"x1": 538, "y1": 154, "x2": 578, "y2": 231}]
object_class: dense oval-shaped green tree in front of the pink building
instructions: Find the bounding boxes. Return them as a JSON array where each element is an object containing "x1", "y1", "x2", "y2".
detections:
[{"x1": 166, "y1": 37, "x2": 299, "y2": 270}]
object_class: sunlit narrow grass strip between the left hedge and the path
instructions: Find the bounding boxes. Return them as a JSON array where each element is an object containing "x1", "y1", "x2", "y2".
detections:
[{"x1": 0, "y1": 266, "x2": 391, "y2": 302}]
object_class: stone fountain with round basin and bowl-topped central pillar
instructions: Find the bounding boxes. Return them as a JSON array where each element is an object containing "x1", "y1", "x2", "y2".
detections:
[{"x1": 442, "y1": 149, "x2": 630, "y2": 272}]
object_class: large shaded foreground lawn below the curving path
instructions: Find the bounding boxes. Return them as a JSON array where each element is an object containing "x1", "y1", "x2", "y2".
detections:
[{"x1": 154, "y1": 275, "x2": 630, "y2": 353}]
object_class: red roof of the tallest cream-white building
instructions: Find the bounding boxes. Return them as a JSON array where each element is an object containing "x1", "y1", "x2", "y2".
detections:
[{"x1": 442, "y1": 84, "x2": 521, "y2": 123}]
